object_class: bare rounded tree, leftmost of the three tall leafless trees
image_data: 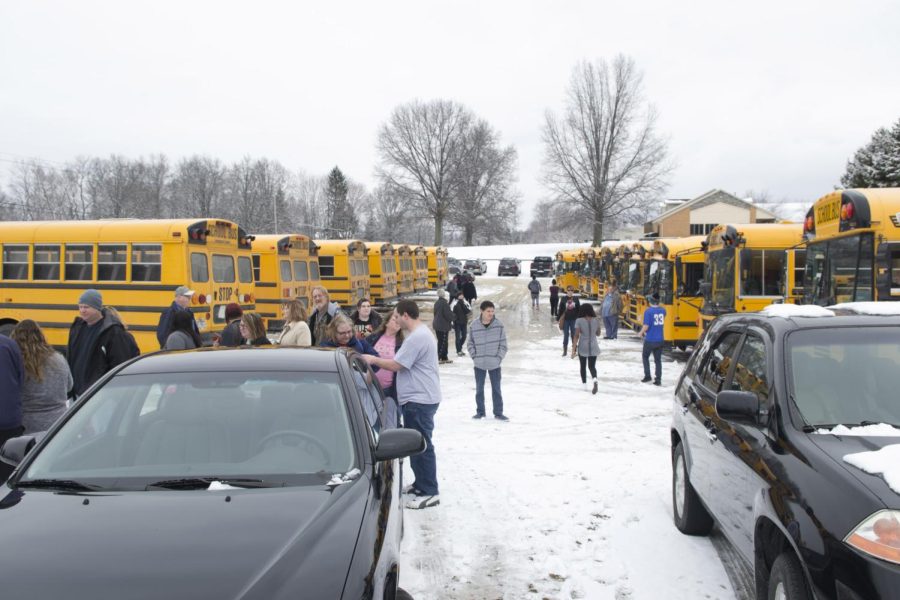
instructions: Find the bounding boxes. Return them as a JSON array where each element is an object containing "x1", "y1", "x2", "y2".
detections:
[{"x1": 377, "y1": 100, "x2": 473, "y2": 244}]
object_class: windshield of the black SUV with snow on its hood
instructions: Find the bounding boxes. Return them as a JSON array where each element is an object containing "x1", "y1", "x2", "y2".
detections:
[{"x1": 788, "y1": 327, "x2": 900, "y2": 427}]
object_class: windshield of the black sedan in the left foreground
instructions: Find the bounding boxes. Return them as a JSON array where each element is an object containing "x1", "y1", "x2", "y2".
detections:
[{"x1": 20, "y1": 372, "x2": 355, "y2": 489}]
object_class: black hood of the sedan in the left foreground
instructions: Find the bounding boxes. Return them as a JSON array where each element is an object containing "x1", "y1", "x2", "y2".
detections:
[{"x1": 0, "y1": 477, "x2": 368, "y2": 600}]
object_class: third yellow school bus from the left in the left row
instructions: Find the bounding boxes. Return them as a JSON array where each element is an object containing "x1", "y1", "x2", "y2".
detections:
[{"x1": 315, "y1": 240, "x2": 369, "y2": 308}]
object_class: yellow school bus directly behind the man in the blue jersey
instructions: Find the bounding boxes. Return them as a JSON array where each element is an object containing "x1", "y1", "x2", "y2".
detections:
[{"x1": 640, "y1": 235, "x2": 706, "y2": 350}]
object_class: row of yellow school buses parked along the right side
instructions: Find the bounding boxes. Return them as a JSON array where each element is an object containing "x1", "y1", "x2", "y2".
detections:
[{"x1": 556, "y1": 188, "x2": 900, "y2": 349}]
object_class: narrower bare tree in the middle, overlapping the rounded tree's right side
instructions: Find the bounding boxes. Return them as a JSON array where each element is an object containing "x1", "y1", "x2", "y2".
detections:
[{"x1": 450, "y1": 120, "x2": 517, "y2": 246}]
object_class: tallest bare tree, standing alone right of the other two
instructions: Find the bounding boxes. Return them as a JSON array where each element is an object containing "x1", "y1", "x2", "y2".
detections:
[{"x1": 543, "y1": 55, "x2": 671, "y2": 244}]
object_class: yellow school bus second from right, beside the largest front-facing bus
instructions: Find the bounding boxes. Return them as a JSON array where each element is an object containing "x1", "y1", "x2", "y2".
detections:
[{"x1": 700, "y1": 223, "x2": 806, "y2": 329}]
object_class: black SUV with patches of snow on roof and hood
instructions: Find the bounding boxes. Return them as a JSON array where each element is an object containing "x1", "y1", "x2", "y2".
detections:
[{"x1": 671, "y1": 303, "x2": 900, "y2": 599}]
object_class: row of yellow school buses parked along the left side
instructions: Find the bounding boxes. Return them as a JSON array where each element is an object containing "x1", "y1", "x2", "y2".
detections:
[{"x1": 0, "y1": 219, "x2": 447, "y2": 352}]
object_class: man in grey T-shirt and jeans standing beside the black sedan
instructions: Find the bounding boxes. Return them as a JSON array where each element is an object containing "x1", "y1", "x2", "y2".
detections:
[{"x1": 362, "y1": 300, "x2": 441, "y2": 509}]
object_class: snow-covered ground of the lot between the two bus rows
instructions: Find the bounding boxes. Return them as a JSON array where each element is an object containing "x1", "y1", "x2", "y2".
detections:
[{"x1": 401, "y1": 274, "x2": 735, "y2": 600}]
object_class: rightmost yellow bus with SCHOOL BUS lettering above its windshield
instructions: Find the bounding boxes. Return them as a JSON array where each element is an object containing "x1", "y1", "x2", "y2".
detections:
[{"x1": 803, "y1": 188, "x2": 900, "y2": 306}]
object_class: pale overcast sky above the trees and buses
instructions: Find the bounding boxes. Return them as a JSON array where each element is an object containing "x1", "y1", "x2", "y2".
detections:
[{"x1": 0, "y1": 0, "x2": 900, "y2": 224}]
